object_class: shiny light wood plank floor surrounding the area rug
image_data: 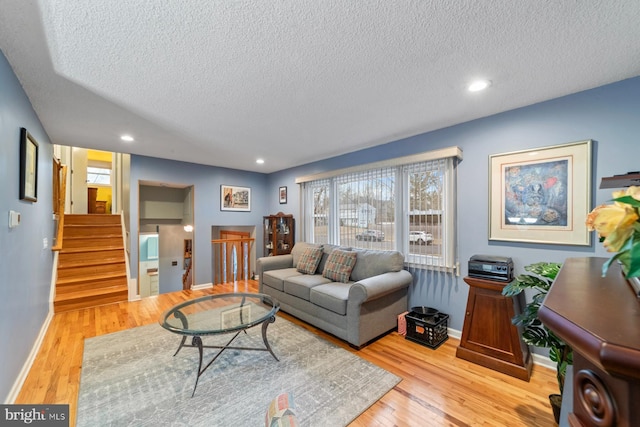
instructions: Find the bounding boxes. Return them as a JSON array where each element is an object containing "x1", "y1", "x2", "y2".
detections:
[{"x1": 15, "y1": 281, "x2": 557, "y2": 427}]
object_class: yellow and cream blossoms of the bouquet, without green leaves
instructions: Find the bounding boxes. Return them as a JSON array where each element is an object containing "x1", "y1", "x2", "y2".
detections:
[{"x1": 587, "y1": 187, "x2": 640, "y2": 252}]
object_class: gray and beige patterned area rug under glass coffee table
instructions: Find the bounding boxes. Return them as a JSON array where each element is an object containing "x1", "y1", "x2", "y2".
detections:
[{"x1": 77, "y1": 318, "x2": 400, "y2": 427}]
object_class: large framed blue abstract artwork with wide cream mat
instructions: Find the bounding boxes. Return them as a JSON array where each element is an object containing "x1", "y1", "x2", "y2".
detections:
[{"x1": 489, "y1": 140, "x2": 592, "y2": 246}]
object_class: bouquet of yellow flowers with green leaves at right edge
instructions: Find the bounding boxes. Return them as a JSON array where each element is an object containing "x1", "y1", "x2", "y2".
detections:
[{"x1": 587, "y1": 186, "x2": 640, "y2": 279}]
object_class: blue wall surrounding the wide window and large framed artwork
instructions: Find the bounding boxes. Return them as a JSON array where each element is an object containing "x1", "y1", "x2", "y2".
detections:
[{"x1": 267, "y1": 78, "x2": 640, "y2": 338}]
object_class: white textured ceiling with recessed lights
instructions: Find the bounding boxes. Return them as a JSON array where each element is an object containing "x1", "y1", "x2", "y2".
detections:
[{"x1": 0, "y1": 0, "x2": 640, "y2": 172}]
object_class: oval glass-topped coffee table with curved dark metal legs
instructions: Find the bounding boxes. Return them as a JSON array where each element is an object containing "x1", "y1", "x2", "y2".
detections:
[{"x1": 159, "y1": 293, "x2": 280, "y2": 397}]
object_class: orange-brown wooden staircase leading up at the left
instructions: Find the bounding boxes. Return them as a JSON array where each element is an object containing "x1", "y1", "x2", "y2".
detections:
[{"x1": 53, "y1": 214, "x2": 128, "y2": 313}]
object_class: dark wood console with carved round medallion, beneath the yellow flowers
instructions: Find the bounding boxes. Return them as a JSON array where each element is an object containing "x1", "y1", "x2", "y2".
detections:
[{"x1": 538, "y1": 258, "x2": 640, "y2": 427}]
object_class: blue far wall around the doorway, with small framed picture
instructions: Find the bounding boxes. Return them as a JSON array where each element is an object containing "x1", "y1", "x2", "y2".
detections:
[{"x1": 129, "y1": 156, "x2": 268, "y2": 285}]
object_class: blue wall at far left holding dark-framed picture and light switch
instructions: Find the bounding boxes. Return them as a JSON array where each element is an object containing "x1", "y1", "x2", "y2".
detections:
[{"x1": 0, "y1": 53, "x2": 53, "y2": 402}]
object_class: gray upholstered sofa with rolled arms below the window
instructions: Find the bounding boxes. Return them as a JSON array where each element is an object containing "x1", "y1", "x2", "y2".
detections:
[{"x1": 256, "y1": 242, "x2": 413, "y2": 348}]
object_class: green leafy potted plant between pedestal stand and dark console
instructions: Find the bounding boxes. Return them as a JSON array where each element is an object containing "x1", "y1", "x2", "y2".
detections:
[{"x1": 502, "y1": 262, "x2": 573, "y2": 422}]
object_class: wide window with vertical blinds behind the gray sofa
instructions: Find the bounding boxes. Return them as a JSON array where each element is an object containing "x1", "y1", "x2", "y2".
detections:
[{"x1": 296, "y1": 147, "x2": 462, "y2": 271}]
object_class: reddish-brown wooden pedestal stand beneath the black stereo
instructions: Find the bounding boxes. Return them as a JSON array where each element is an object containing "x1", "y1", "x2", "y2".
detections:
[{"x1": 456, "y1": 277, "x2": 533, "y2": 381}]
